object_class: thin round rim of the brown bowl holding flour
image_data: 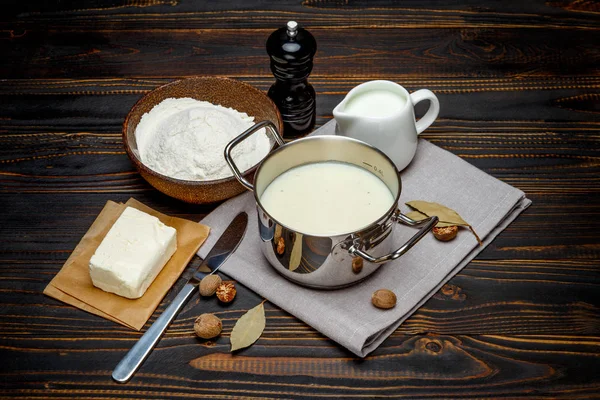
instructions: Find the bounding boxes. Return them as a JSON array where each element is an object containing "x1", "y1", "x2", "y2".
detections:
[{"x1": 121, "y1": 76, "x2": 283, "y2": 186}]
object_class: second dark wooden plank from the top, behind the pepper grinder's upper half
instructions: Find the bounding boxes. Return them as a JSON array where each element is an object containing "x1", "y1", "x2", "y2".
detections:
[{"x1": 0, "y1": 28, "x2": 600, "y2": 79}]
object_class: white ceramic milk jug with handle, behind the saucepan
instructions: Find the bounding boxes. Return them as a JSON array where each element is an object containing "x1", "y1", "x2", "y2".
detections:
[{"x1": 333, "y1": 80, "x2": 440, "y2": 170}]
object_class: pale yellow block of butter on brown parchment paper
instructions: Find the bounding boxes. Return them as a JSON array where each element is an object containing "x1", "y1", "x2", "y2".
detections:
[{"x1": 90, "y1": 207, "x2": 177, "y2": 299}]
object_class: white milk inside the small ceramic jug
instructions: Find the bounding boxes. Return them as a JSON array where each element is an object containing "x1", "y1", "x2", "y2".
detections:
[{"x1": 343, "y1": 90, "x2": 406, "y2": 118}]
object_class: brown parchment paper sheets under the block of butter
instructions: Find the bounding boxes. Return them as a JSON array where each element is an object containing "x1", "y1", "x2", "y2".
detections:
[{"x1": 44, "y1": 199, "x2": 210, "y2": 331}]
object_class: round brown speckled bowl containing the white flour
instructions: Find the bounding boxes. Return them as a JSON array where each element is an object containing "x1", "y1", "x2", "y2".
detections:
[{"x1": 123, "y1": 77, "x2": 283, "y2": 204}]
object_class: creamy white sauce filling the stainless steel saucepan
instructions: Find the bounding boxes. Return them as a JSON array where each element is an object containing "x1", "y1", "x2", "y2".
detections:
[{"x1": 260, "y1": 161, "x2": 394, "y2": 236}]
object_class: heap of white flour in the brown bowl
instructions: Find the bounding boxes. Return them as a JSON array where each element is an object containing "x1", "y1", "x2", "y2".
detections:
[{"x1": 135, "y1": 98, "x2": 271, "y2": 181}]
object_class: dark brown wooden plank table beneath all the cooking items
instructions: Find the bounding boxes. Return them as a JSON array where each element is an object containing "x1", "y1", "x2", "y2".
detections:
[{"x1": 0, "y1": 0, "x2": 600, "y2": 399}]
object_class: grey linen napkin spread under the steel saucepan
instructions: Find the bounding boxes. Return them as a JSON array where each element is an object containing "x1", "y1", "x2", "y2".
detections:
[{"x1": 198, "y1": 121, "x2": 531, "y2": 357}]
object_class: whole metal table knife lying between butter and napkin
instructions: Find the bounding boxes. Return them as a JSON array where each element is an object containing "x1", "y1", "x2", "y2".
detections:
[{"x1": 112, "y1": 212, "x2": 248, "y2": 383}]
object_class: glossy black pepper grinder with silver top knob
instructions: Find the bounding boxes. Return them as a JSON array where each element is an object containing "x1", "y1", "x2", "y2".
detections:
[{"x1": 267, "y1": 21, "x2": 317, "y2": 141}]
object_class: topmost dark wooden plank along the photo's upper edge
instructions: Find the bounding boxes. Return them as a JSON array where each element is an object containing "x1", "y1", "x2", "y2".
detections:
[{"x1": 0, "y1": 0, "x2": 599, "y2": 29}]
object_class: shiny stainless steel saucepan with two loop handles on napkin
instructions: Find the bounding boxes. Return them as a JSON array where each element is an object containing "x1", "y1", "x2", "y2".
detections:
[{"x1": 225, "y1": 121, "x2": 438, "y2": 289}]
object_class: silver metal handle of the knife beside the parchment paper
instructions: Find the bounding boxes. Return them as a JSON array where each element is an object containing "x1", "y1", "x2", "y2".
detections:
[{"x1": 112, "y1": 283, "x2": 197, "y2": 383}]
